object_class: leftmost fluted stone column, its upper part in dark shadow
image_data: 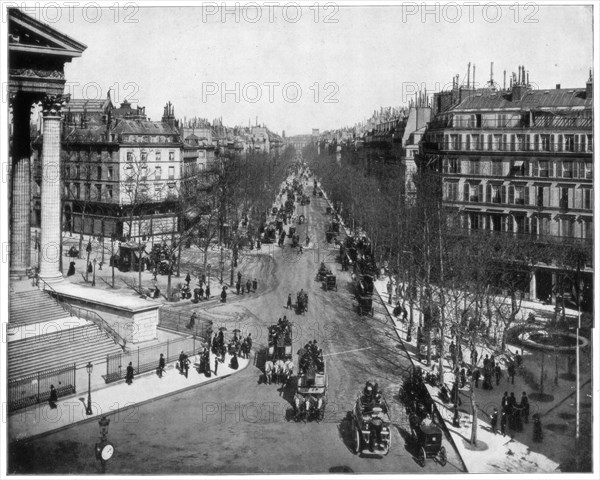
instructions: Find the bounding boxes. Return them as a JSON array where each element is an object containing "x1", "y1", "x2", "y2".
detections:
[{"x1": 10, "y1": 93, "x2": 33, "y2": 280}]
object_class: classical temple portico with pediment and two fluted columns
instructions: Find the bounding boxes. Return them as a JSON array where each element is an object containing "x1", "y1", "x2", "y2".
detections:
[{"x1": 8, "y1": 8, "x2": 87, "y2": 282}]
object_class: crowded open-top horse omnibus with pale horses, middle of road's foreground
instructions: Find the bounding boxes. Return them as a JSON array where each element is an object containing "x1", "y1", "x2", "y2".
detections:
[{"x1": 294, "y1": 349, "x2": 327, "y2": 422}]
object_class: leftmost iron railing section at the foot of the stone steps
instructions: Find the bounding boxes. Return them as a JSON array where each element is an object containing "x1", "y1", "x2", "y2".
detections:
[{"x1": 7, "y1": 364, "x2": 76, "y2": 412}]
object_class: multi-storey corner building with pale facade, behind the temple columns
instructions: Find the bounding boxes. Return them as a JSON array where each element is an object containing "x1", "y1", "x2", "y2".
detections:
[{"x1": 33, "y1": 101, "x2": 187, "y2": 239}]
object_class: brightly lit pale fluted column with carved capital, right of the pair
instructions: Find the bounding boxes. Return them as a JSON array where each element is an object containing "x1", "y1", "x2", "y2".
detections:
[{"x1": 40, "y1": 95, "x2": 66, "y2": 283}]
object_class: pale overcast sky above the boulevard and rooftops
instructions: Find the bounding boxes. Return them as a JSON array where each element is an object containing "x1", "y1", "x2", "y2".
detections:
[{"x1": 36, "y1": 2, "x2": 593, "y2": 135}]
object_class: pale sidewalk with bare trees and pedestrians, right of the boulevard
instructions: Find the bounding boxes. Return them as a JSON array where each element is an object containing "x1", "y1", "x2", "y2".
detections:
[{"x1": 375, "y1": 278, "x2": 591, "y2": 473}]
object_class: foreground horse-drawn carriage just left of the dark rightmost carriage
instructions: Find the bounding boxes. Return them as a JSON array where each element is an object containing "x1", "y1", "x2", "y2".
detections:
[{"x1": 351, "y1": 382, "x2": 392, "y2": 455}]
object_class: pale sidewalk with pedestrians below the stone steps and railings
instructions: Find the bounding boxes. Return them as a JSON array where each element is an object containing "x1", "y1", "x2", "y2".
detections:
[{"x1": 7, "y1": 354, "x2": 252, "y2": 442}]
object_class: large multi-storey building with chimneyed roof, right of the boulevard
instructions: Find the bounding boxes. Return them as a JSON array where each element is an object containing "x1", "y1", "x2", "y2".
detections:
[{"x1": 419, "y1": 67, "x2": 594, "y2": 308}]
